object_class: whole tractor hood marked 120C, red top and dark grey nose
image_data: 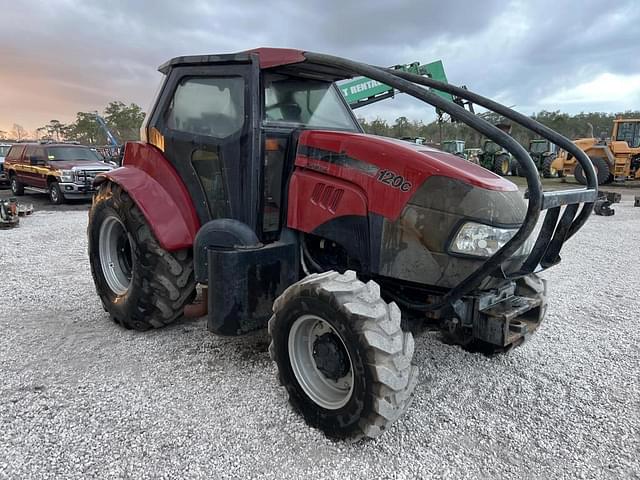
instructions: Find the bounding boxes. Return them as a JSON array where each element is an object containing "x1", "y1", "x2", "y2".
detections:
[{"x1": 291, "y1": 131, "x2": 527, "y2": 288}]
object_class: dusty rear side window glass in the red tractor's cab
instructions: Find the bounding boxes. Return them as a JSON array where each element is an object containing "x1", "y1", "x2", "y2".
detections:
[{"x1": 165, "y1": 77, "x2": 245, "y2": 138}]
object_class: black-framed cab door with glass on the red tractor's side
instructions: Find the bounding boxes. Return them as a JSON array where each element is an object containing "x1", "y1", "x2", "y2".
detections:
[{"x1": 148, "y1": 61, "x2": 260, "y2": 230}]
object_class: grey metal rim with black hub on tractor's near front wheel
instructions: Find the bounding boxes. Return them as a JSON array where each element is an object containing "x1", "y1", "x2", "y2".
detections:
[{"x1": 288, "y1": 315, "x2": 354, "y2": 410}]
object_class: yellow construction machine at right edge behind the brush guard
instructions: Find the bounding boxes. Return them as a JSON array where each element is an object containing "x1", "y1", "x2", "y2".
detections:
[{"x1": 551, "y1": 118, "x2": 640, "y2": 185}]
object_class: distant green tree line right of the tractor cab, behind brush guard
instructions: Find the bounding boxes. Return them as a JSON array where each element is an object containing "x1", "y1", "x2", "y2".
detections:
[{"x1": 358, "y1": 111, "x2": 640, "y2": 148}]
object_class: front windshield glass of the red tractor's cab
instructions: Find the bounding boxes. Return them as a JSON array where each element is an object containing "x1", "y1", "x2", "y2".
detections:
[{"x1": 264, "y1": 75, "x2": 360, "y2": 132}]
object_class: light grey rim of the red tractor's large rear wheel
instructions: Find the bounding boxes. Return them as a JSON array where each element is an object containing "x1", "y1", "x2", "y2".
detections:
[{"x1": 98, "y1": 217, "x2": 133, "y2": 295}]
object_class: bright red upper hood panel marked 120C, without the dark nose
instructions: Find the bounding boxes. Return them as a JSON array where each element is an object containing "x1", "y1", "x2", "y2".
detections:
[{"x1": 296, "y1": 130, "x2": 518, "y2": 219}]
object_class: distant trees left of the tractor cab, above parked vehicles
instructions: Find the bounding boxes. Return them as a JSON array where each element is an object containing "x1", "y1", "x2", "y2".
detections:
[{"x1": 0, "y1": 101, "x2": 144, "y2": 146}]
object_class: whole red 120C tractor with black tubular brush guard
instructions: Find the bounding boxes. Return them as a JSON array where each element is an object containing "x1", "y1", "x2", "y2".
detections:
[{"x1": 88, "y1": 48, "x2": 597, "y2": 439}]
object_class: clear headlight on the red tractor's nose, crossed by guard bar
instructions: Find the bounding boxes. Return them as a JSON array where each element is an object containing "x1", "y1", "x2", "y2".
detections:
[{"x1": 449, "y1": 222, "x2": 534, "y2": 257}]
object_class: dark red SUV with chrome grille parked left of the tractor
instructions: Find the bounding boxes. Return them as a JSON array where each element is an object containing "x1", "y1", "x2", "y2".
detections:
[{"x1": 5, "y1": 143, "x2": 113, "y2": 204}]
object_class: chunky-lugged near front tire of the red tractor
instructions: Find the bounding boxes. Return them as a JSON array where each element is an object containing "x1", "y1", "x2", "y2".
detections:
[{"x1": 269, "y1": 271, "x2": 418, "y2": 440}]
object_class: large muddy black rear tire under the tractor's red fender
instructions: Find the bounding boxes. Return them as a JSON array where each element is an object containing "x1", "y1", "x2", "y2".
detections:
[{"x1": 87, "y1": 182, "x2": 195, "y2": 330}]
